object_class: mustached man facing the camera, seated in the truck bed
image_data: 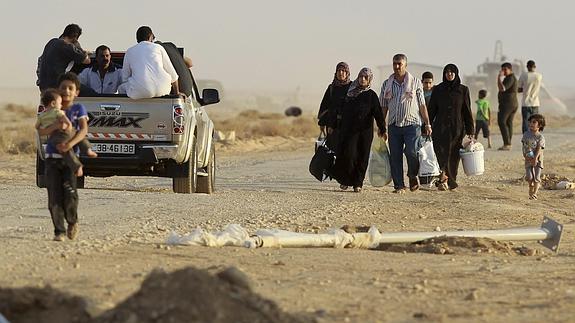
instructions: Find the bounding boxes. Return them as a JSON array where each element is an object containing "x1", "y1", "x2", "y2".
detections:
[{"x1": 78, "y1": 45, "x2": 122, "y2": 94}]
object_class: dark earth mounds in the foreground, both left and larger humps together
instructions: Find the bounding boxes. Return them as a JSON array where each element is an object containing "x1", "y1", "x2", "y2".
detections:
[{"x1": 0, "y1": 267, "x2": 313, "y2": 323}]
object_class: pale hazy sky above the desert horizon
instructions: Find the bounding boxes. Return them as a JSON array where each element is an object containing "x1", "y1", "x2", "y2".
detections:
[{"x1": 0, "y1": 0, "x2": 575, "y2": 97}]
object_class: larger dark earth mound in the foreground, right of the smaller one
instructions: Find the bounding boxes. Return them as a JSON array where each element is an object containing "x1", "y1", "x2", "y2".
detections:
[{"x1": 96, "y1": 268, "x2": 305, "y2": 323}]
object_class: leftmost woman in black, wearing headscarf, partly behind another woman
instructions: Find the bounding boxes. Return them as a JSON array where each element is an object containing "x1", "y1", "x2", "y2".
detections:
[{"x1": 317, "y1": 62, "x2": 351, "y2": 151}]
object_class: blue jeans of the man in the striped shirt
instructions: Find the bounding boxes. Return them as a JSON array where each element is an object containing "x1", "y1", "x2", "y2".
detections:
[{"x1": 389, "y1": 125, "x2": 421, "y2": 189}]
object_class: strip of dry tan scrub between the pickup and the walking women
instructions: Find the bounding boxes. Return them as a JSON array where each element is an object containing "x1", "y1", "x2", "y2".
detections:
[{"x1": 214, "y1": 110, "x2": 319, "y2": 139}]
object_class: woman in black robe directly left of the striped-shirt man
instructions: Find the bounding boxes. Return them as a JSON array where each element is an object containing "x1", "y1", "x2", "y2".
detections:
[{"x1": 328, "y1": 67, "x2": 385, "y2": 193}]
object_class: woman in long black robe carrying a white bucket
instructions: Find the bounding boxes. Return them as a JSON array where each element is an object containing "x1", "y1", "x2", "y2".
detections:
[{"x1": 428, "y1": 64, "x2": 473, "y2": 191}]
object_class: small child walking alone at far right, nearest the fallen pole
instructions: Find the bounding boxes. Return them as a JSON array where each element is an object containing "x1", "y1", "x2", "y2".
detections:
[{"x1": 521, "y1": 114, "x2": 545, "y2": 200}]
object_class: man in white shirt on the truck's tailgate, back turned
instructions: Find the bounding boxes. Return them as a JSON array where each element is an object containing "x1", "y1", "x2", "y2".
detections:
[{"x1": 118, "y1": 26, "x2": 179, "y2": 99}]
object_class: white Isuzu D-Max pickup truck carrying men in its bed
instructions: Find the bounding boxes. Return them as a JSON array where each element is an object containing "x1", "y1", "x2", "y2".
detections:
[{"x1": 36, "y1": 43, "x2": 219, "y2": 194}]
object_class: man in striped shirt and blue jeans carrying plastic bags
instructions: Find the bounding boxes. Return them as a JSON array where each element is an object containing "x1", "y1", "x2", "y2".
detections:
[{"x1": 379, "y1": 54, "x2": 431, "y2": 193}]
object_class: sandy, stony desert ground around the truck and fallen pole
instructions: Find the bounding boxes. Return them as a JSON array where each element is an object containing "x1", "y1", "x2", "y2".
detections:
[{"x1": 0, "y1": 104, "x2": 575, "y2": 322}]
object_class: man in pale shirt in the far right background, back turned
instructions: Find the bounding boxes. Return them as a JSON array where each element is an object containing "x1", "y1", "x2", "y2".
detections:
[{"x1": 517, "y1": 60, "x2": 543, "y2": 133}]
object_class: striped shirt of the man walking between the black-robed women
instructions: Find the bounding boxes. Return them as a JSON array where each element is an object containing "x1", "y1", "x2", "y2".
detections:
[{"x1": 379, "y1": 77, "x2": 425, "y2": 127}]
